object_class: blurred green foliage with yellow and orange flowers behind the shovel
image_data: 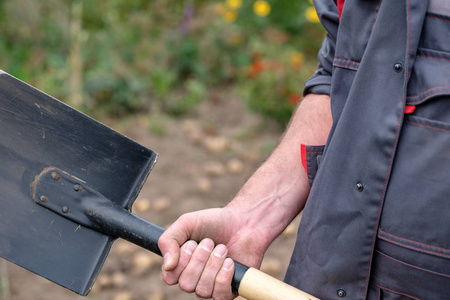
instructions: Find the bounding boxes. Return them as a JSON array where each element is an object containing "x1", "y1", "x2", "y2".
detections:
[{"x1": 0, "y1": 0, "x2": 324, "y2": 124}]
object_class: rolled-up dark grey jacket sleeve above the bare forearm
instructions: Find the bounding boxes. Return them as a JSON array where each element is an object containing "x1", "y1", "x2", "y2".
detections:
[{"x1": 303, "y1": 0, "x2": 339, "y2": 96}]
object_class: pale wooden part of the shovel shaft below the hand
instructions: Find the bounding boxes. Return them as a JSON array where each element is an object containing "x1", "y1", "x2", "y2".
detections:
[{"x1": 238, "y1": 268, "x2": 318, "y2": 300}]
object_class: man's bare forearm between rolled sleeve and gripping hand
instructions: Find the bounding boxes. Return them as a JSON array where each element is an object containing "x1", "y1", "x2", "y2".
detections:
[{"x1": 227, "y1": 95, "x2": 332, "y2": 246}]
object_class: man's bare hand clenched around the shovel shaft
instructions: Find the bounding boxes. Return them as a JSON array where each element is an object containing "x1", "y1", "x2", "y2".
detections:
[{"x1": 159, "y1": 208, "x2": 267, "y2": 300}]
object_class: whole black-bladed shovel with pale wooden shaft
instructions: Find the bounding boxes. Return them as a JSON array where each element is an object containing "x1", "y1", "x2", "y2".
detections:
[{"x1": 0, "y1": 70, "x2": 317, "y2": 300}]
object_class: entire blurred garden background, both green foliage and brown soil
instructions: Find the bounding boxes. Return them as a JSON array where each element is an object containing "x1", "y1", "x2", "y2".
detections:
[{"x1": 0, "y1": 0, "x2": 325, "y2": 300}]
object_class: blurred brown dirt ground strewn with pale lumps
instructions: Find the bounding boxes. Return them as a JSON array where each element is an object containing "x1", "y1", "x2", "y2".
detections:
[{"x1": 0, "y1": 93, "x2": 298, "y2": 300}]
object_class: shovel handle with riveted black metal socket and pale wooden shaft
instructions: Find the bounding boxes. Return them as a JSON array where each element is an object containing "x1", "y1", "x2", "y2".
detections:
[{"x1": 32, "y1": 168, "x2": 317, "y2": 300}]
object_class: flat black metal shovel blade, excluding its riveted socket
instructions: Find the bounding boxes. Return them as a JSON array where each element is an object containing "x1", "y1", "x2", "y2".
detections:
[{"x1": 0, "y1": 71, "x2": 157, "y2": 295}]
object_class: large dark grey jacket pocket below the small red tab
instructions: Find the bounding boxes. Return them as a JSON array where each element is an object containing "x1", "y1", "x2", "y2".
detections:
[{"x1": 380, "y1": 112, "x2": 450, "y2": 262}]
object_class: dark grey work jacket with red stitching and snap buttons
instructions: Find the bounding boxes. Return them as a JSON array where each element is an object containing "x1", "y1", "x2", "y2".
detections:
[{"x1": 285, "y1": 0, "x2": 450, "y2": 299}]
